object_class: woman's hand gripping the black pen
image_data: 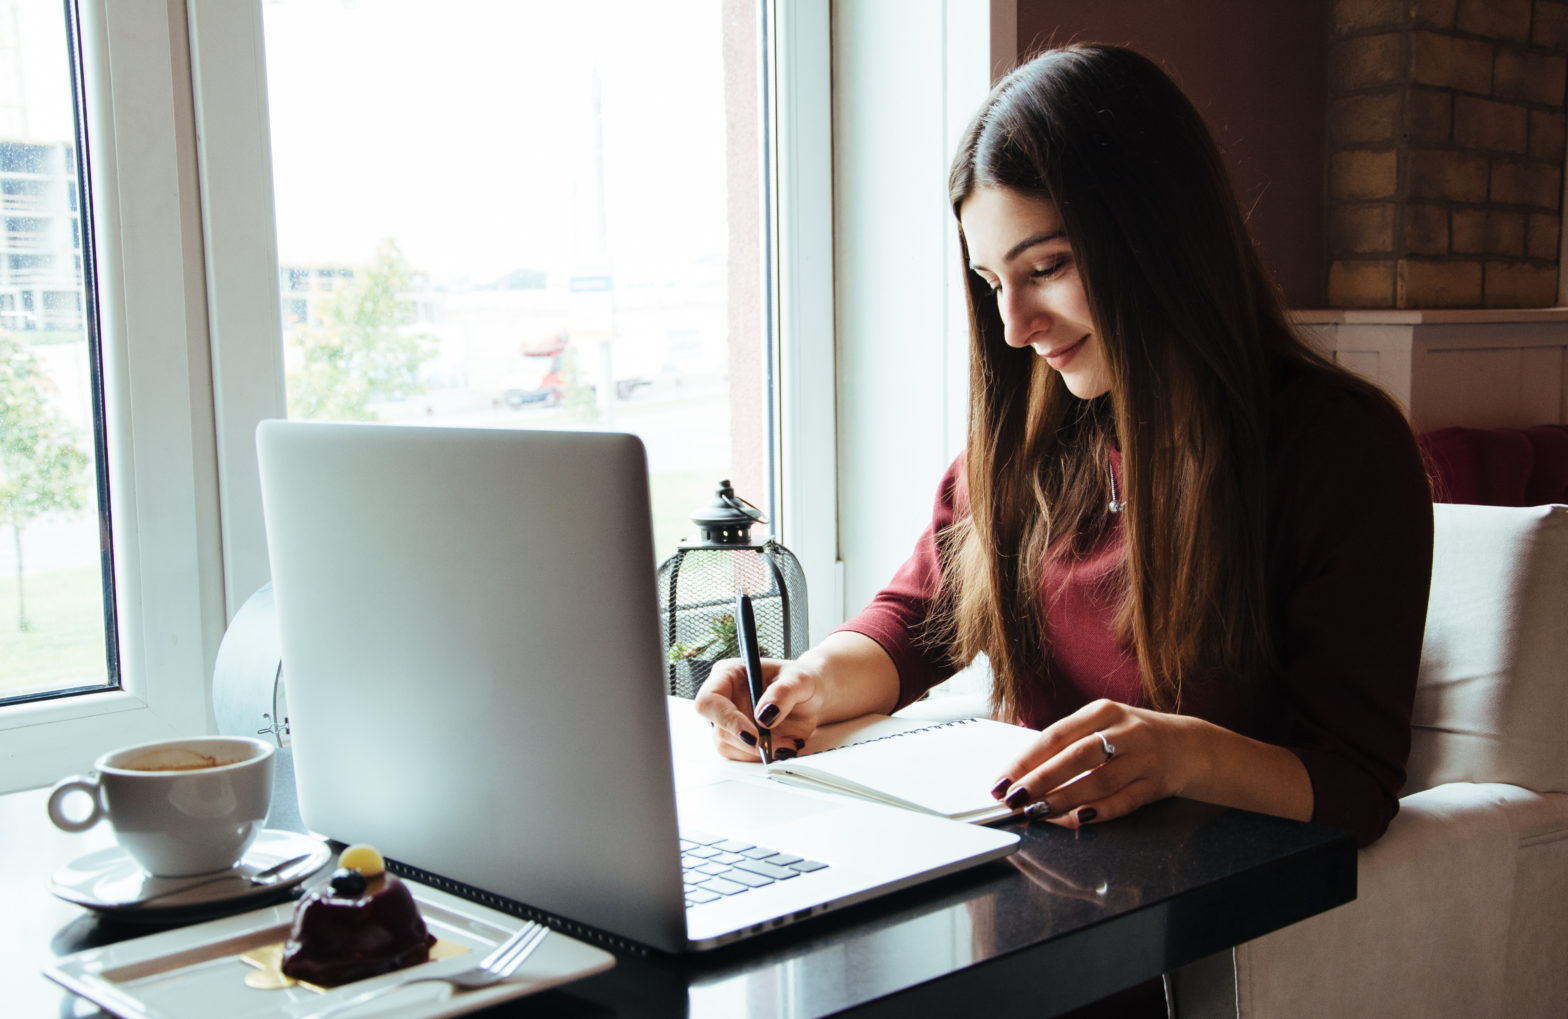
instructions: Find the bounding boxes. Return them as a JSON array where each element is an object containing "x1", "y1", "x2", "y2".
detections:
[{"x1": 696, "y1": 658, "x2": 823, "y2": 760}]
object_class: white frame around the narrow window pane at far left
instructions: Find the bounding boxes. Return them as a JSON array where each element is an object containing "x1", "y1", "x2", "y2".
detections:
[{"x1": 0, "y1": 0, "x2": 224, "y2": 790}]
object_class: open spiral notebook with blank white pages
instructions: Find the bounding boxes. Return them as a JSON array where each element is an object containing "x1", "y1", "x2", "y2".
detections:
[{"x1": 767, "y1": 718, "x2": 1040, "y2": 825}]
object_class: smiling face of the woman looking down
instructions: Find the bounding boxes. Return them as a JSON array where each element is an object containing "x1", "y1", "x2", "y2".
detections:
[{"x1": 958, "y1": 187, "x2": 1110, "y2": 400}]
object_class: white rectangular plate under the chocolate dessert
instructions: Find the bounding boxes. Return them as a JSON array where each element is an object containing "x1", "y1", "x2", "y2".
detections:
[{"x1": 44, "y1": 881, "x2": 615, "y2": 1019}]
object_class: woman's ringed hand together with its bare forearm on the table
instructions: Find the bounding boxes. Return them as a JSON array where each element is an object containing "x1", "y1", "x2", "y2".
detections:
[{"x1": 991, "y1": 701, "x2": 1312, "y2": 828}]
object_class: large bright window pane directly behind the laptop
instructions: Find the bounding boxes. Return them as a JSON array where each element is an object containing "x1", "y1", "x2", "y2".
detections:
[{"x1": 262, "y1": 0, "x2": 775, "y2": 557}]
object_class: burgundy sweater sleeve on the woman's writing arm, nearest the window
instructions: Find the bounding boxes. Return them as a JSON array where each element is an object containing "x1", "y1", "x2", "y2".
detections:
[{"x1": 834, "y1": 456, "x2": 963, "y2": 707}]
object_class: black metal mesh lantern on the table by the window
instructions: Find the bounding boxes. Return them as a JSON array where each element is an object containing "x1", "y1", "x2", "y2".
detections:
[{"x1": 659, "y1": 481, "x2": 808, "y2": 698}]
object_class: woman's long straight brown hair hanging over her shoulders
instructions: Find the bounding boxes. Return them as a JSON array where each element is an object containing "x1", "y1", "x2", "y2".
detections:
[{"x1": 938, "y1": 45, "x2": 1361, "y2": 715}]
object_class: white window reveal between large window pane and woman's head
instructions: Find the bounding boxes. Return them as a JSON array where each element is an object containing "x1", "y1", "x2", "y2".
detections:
[{"x1": 828, "y1": 0, "x2": 1018, "y2": 613}]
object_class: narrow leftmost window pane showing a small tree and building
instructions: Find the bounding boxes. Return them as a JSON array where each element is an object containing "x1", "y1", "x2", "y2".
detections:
[{"x1": 0, "y1": 0, "x2": 119, "y2": 702}]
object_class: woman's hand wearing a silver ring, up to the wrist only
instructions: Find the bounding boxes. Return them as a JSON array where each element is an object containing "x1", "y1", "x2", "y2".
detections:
[{"x1": 991, "y1": 701, "x2": 1207, "y2": 828}]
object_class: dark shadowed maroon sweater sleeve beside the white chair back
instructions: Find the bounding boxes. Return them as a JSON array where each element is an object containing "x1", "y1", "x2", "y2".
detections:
[{"x1": 1272, "y1": 385, "x2": 1432, "y2": 845}]
